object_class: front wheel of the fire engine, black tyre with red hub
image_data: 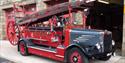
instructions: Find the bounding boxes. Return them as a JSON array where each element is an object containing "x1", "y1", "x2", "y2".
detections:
[{"x1": 66, "y1": 48, "x2": 89, "y2": 63}]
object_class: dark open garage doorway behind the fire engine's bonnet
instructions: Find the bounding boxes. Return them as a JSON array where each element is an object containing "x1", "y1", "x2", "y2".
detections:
[{"x1": 87, "y1": 2, "x2": 123, "y2": 50}]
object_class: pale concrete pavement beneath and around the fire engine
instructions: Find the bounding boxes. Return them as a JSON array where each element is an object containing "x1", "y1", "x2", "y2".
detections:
[{"x1": 0, "y1": 40, "x2": 125, "y2": 63}]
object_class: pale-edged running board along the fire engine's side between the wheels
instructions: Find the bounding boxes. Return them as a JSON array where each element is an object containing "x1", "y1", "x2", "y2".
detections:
[{"x1": 28, "y1": 45, "x2": 56, "y2": 53}]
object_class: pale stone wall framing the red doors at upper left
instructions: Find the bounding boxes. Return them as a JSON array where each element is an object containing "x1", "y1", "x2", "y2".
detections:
[{"x1": 0, "y1": 0, "x2": 47, "y2": 40}]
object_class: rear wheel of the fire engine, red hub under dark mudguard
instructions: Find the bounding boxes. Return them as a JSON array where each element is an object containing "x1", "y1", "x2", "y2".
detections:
[{"x1": 19, "y1": 41, "x2": 29, "y2": 56}]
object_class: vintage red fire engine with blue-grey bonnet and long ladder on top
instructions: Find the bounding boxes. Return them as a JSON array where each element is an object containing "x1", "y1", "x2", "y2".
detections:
[{"x1": 7, "y1": 0, "x2": 113, "y2": 63}]
